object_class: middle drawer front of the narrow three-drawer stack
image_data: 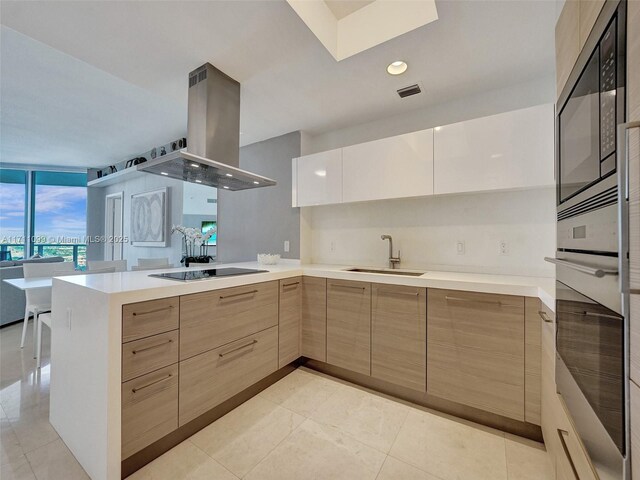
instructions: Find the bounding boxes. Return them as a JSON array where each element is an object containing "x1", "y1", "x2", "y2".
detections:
[{"x1": 122, "y1": 330, "x2": 178, "y2": 382}]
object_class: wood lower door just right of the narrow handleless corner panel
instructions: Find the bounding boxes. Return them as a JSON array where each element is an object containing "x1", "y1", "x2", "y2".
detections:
[{"x1": 327, "y1": 279, "x2": 371, "y2": 375}]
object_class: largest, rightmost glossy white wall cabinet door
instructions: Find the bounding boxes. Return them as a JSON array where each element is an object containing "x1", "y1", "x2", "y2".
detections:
[{"x1": 434, "y1": 104, "x2": 555, "y2": 194}]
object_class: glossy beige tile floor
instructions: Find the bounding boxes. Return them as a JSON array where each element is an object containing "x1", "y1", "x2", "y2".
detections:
[{"x1": 0, "y1": 320, "x2": 552, "y2": 480}]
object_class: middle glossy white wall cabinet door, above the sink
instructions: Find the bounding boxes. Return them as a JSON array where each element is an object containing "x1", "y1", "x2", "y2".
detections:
[{"x1": 342, "y1": 129, "x2": 433, "y2": 202}]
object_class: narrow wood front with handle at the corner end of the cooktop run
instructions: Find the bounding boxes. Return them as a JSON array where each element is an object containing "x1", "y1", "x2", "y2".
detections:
[{"x1": 278, "y1": 277, "x2": 302, "y2": 368}]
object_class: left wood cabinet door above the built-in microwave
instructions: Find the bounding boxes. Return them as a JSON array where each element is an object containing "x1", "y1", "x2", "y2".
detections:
[{"x1": 556, "y1": 0, "x2": 580, "y2": 98}]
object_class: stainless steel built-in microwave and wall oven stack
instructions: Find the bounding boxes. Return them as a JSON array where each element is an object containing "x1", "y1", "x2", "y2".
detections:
[{"x1": 548, "y1": 0, "x2": 629, "y2": 479}]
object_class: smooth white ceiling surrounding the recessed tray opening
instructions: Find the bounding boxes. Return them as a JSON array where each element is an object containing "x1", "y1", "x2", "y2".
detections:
[{"x1": 0, "y1": 0, "x2": 556, "y2": 166}]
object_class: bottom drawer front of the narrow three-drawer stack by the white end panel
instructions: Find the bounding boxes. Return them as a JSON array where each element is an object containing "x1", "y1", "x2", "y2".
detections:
[{"x1": 122, "y1": 364, "x2": 178, "y2": 459}]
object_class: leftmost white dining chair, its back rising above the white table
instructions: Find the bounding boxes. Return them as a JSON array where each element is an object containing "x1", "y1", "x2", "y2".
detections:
[{"x1": 20, "y1": 262, "x2": 75, "y2": 348}]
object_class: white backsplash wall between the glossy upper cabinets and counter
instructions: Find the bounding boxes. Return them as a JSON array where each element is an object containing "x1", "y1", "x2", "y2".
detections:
[{"x1": 301, "y1": 188, "x2": 556, "y2": 277}]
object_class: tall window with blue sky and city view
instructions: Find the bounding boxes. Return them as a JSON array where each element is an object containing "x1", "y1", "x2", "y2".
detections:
[{"x1": 0, "y1": 169, "x2": 87, "y2": 268}]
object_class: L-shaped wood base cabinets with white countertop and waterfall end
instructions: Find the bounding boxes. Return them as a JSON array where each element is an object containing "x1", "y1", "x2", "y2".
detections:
[{"x1": 50, "y1": 263, "x2": 554, "y2": 479}]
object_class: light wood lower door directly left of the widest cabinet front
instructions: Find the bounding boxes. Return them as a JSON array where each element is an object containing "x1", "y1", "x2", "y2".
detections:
[{"x1": 371, "y1": 284, "x2": 427, "y2": 392}]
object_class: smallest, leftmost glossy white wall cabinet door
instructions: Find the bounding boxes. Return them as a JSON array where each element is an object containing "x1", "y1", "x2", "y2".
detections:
[{"x1": 292, "y1": 148, "x2": 342, "y2": 207}]
